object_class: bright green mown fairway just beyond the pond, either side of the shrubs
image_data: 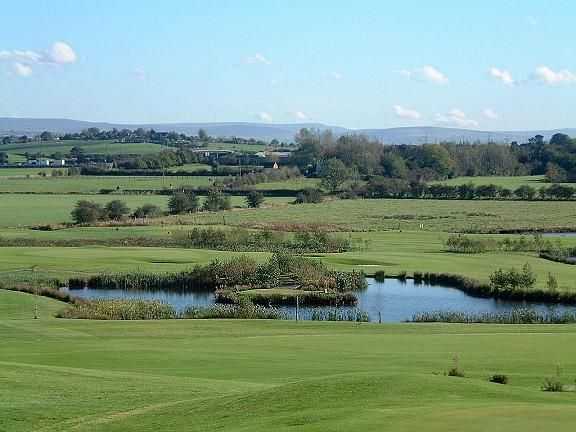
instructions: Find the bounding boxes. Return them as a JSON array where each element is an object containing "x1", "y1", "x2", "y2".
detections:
[{"x1": 0, "y1": 231, "x2": 576, "y2": 291}]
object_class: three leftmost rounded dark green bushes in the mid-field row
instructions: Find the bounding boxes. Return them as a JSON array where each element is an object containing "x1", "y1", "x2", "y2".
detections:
[{"x1": 71, "y1": 200, "x2": 163, "y2": 224}]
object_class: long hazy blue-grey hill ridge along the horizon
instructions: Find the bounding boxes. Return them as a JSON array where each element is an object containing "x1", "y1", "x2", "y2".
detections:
[{"x1": 0, "y1": 117, "x2": 576, "y2": 144}]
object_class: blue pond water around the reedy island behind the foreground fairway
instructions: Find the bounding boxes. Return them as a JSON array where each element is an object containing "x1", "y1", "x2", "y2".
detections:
[{"x1": 64, "y1": 279, "x2": 576, "y2": 322}]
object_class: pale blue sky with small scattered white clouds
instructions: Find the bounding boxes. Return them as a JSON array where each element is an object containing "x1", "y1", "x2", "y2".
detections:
[{"x1": 0, "y1": 0, "x2": 576, "y2": 130}]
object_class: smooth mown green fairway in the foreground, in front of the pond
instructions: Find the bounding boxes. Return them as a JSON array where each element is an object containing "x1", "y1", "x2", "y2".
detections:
[{"x1": 0, "y1": 291, "x2": 576, "y2": 432}]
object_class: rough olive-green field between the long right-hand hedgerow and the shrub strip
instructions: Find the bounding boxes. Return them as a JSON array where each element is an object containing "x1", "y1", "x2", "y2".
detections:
[{"x1": 189, "y1": 199, "x2": 576, "y2": 232}]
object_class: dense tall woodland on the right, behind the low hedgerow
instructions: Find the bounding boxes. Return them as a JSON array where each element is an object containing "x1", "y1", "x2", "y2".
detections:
[{"x1": 291, "y1": 129, "x2": 576, "y2": 183}]
